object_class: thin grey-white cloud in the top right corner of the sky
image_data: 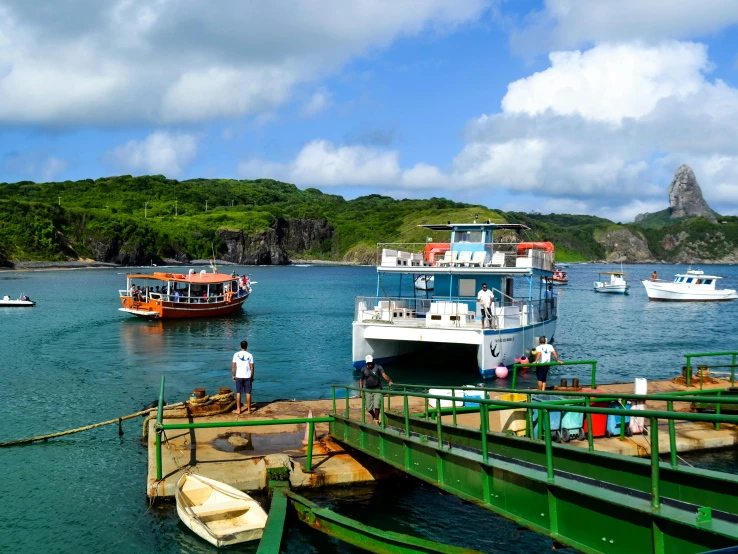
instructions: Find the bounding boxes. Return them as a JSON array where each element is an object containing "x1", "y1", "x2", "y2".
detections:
[{"x1": 512, "y1": 0, "x2": 738, "y2": 52}]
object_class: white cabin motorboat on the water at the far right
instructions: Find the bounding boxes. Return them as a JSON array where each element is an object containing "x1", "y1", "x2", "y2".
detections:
[{"x1": 642, "y1": 270, "x2": 738, "y2": 302}]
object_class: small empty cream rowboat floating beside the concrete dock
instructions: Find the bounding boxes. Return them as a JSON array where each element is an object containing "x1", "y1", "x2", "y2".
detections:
[{"x1": 176, "y1": 473, "x2": 267, "y2": 547}]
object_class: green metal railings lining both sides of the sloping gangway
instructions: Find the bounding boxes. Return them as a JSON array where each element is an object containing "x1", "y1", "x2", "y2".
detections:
[{"x1": 331, "y1": 384, "x2": 738, "y2": 476}]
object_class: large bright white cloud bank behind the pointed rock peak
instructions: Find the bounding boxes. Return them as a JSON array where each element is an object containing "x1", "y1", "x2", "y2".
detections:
[{"x1": 241, "y1": 41, "x2": 738, "y2": 221}]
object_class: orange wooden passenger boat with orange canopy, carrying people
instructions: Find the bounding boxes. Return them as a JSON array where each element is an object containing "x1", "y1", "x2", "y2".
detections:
[{"x1": 119, "y1": 269, "x2": 251, "y2": 319}]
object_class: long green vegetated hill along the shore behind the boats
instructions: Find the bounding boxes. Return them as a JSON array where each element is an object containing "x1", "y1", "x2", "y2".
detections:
[{"x1": 0, "y1": 175, "x2": 738, "y2": 265}]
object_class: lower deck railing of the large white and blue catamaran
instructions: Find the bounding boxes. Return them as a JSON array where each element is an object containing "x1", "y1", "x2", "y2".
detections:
[{"x1": 354, "y1": 291, "x2": 558, "y2": 329}]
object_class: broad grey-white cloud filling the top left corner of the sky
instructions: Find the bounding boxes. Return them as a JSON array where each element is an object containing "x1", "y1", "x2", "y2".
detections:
[{"x1": 0, "y1": 0, "x2": 486, "y2": 125}]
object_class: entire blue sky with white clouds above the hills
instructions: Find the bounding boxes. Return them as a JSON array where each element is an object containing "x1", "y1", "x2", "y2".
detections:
[{"x1": 0, "y1": 0, "x2": 738, "y2": 222}]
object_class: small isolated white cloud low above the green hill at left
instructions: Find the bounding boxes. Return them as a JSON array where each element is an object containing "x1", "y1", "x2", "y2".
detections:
[{"x1": 104, "y1": 131, "x2": 197, "y2": 177}]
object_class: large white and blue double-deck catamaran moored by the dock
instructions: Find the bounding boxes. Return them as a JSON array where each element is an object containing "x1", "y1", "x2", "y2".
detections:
[{"x1": 352, "y1": 223, "x2": 558, "y2": 377}]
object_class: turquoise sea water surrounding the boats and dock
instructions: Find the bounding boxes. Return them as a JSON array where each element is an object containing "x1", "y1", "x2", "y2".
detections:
[{"x1": 0, "y1": 265, "x2": 738, "y2": 553}]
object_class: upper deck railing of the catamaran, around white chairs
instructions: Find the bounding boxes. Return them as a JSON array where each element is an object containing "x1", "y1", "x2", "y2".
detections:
[{"x1": 377, "y1": 242, "x2": 554, "y2": 272}]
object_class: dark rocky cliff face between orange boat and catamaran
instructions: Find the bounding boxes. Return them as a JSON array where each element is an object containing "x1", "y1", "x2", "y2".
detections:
[{"x1": 218, "y1": 219, "x2": 333, "y2": 265}]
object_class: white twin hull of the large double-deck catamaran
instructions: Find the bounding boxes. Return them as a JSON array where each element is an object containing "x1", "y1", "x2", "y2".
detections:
[{"x1": 353, "y1": 317, "x2": 557, "y2": 378}]
